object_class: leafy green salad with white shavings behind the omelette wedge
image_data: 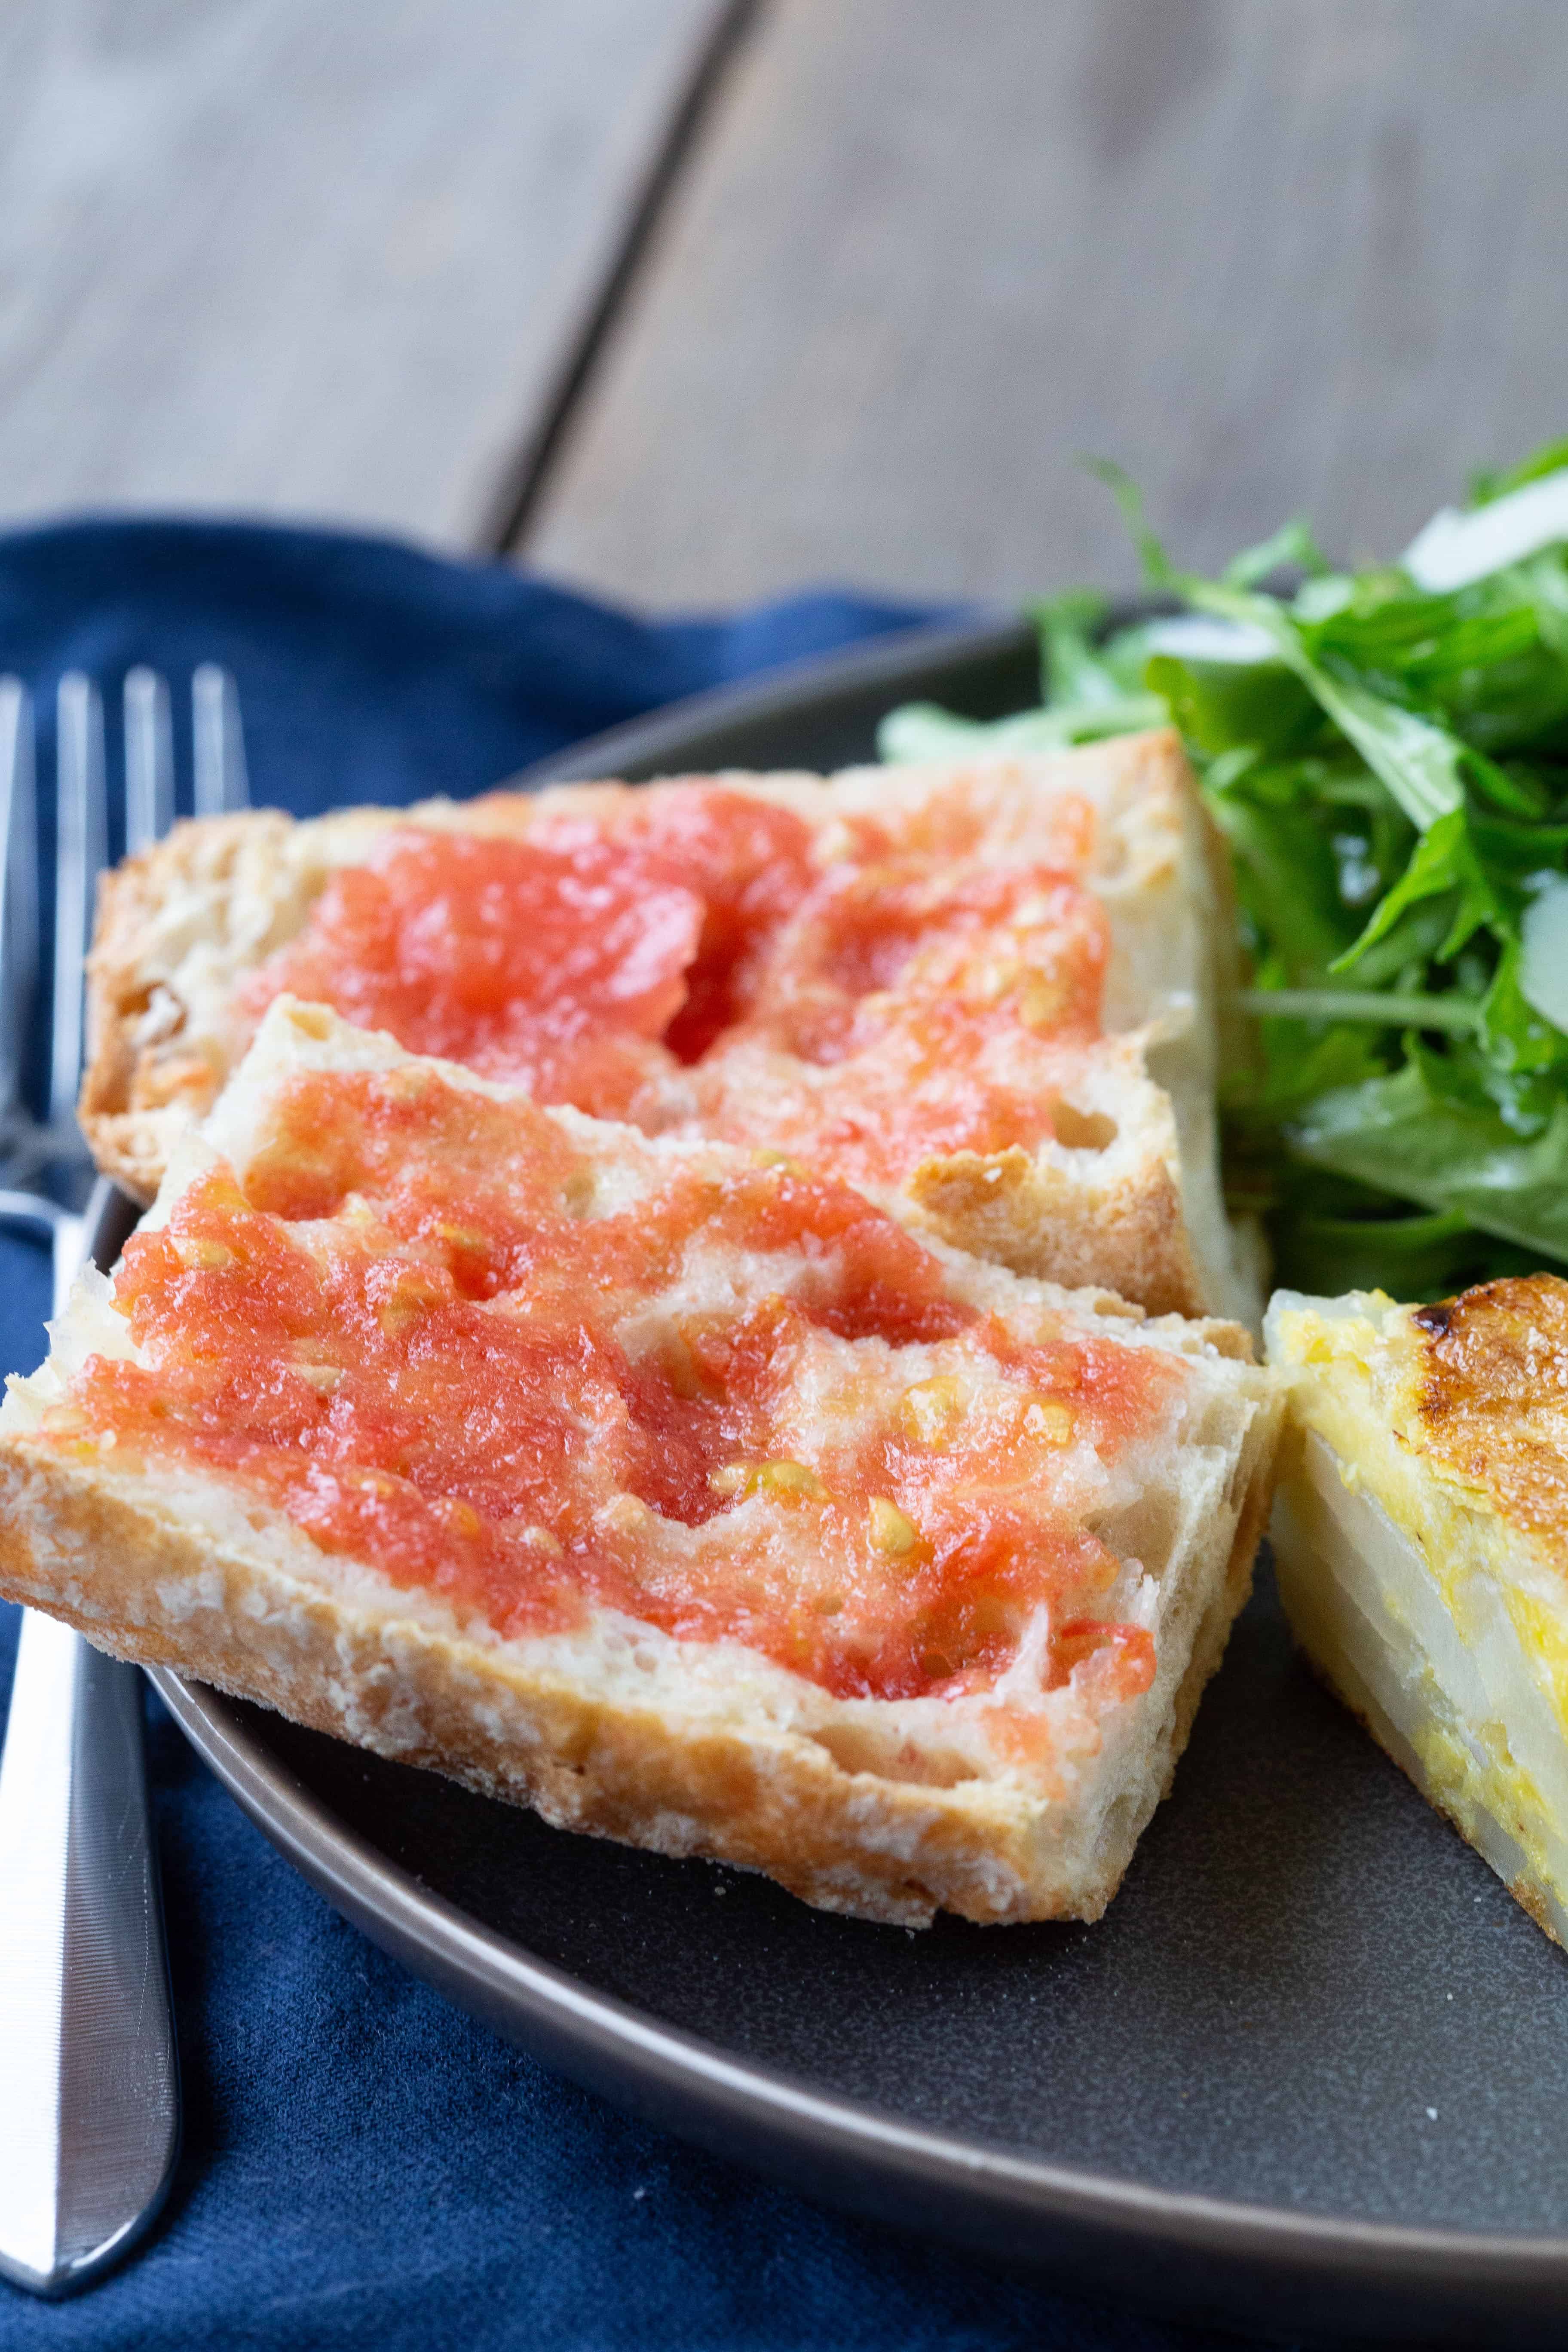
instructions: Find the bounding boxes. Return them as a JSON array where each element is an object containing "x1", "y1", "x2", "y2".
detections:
[{"x1": 882, "y1": 442, "x2": 1568, "y2": 1298}]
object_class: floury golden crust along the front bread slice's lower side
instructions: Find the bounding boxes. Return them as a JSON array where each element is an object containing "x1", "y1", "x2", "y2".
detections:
[{"x1": 0, "y1": 1416, "x2": 1272, "y2": 1926}]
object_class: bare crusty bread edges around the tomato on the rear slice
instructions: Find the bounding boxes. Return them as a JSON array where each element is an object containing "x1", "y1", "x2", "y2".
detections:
[{"x1": 80, "y1": 729, "x2": 1260, "y2": 1324}]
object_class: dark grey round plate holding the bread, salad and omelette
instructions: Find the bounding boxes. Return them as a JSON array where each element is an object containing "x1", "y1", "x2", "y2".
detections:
[{"x1": 129, "y1": 626, "x2": 1568, "y2": 2343}]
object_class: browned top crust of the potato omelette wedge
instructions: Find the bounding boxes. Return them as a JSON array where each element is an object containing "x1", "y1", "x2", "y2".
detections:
[{"x1": 1411, "y1": 1275, "x2": 1568, "y2": 1571}]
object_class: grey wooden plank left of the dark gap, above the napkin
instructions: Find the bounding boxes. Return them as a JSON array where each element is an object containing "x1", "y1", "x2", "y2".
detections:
[{"x1": 0, "y1": 0, "x2": 729, "y2": 546}]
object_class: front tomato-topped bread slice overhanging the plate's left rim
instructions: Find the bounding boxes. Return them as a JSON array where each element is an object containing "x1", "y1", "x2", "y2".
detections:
[{"x1": 0, "y1": 1000, "x2": 1277, "y2": 1924}]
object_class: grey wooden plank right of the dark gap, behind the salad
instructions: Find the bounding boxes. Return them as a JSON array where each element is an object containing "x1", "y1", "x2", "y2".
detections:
[{"x1": 527, "y1": 0, "x2": 1568, "y2": 604}]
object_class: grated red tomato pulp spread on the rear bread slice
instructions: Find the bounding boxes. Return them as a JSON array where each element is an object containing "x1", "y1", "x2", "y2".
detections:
[{"x1": 245, "y1": 783, "x2": 1107, "y2": 1188}]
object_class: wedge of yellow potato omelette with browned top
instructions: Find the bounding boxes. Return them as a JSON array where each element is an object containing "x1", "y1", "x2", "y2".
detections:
[{"x1": 1267, "y1": 1275, "x2": 1568, "y2": 1943}]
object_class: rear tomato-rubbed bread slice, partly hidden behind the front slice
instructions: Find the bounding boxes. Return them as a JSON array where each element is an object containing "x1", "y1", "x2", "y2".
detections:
[{"x1": 82, "y1": 732, "x2": 1260, "y2": 1322}]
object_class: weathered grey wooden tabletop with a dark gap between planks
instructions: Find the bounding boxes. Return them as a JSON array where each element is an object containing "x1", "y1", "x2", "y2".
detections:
[{"x1": 0, "y1": 0, "x2": 1568, "y2": 607}]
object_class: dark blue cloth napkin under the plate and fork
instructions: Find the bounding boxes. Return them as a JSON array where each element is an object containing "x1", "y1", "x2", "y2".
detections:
[{"x1": 0, "y1": 522, "x2": 1241, "y2": 2352}]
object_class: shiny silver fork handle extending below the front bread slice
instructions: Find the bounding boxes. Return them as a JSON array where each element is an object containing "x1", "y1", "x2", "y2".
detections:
[{"x1": 0, "y1": 1185, "x2": 179, "y2": 2296}]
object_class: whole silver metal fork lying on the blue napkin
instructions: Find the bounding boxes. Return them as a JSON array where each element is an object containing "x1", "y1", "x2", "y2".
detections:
[{"x1": 0, "y1": 663, "x2": 247, "y2": 2296}]
